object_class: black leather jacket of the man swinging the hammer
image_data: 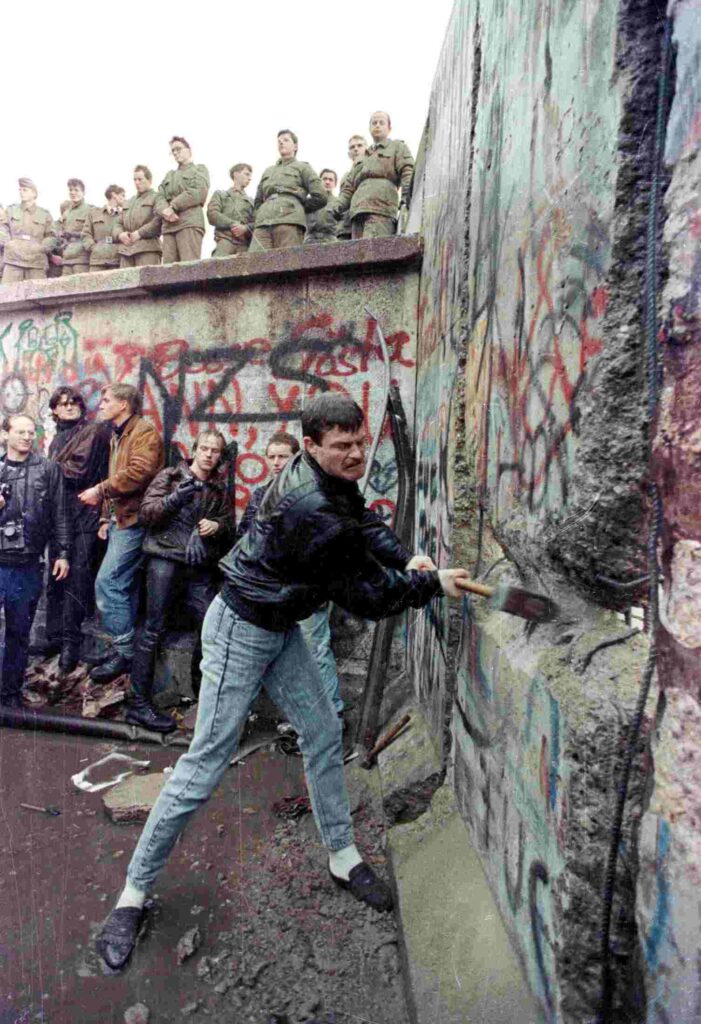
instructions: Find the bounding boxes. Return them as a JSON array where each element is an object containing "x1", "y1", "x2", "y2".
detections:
[{"x1": 219, "y1": 453, "x2": 441, "y2": 632}]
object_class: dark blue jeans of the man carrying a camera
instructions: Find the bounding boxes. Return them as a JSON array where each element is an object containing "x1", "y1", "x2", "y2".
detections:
[{"x1": 0, "y1": 558, "x2": 43, "y2": 700}]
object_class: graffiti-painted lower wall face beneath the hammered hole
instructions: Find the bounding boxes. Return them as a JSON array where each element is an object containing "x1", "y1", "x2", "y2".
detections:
[{"x1": 453, "y1": 602, "x2": 568, "y2": 1021}]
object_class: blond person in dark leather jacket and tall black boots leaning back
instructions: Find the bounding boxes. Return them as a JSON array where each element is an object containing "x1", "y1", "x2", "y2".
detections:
[{"x1": 126, "y1": 430, "x2": 233, "y2": 732}]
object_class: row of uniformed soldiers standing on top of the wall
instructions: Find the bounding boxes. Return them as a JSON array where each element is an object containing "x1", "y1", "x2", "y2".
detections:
[{"x1": 0, "y1": 111, "x2": 413, "y2": 284}]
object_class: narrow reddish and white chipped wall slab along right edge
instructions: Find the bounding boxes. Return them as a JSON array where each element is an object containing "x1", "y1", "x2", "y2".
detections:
[{"x1": 638, "y1": 0, "x2": 701, "y2": 1022}]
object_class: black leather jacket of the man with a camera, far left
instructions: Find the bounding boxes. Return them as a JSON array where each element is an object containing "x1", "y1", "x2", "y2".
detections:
[{"x1": 0, "y1": 452, "x2": 71, "y2": 558}]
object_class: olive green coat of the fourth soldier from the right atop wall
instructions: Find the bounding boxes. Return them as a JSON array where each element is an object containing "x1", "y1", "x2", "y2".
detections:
[{"x1": 254, "y1": 159, "x2": 328, "y2": 228}]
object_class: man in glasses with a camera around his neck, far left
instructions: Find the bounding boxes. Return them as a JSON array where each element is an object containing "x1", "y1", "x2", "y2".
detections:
[{"x1": 0, "y1": 413, "x2": 70, "y2": 708}]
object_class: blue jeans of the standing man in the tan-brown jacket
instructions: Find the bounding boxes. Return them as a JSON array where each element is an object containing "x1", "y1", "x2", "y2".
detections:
[{"x1": 95, "y1": 522, "x2": 146, "y2": 659}]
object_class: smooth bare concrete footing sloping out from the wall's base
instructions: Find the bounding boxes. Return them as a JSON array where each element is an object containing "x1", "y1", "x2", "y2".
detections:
[{"x1": 389, "y1": 786, "x2": 542, "y2": 1024}]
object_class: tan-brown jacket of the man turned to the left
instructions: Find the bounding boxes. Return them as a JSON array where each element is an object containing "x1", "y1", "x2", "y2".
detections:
[{"x1": 97, "y1": 416, "x2": 164, "y2": 529}]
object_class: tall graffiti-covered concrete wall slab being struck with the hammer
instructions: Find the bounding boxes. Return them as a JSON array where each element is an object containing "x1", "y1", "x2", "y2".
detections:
[{"x1": 412, "y1": 0, "x2": 663, "y2": 1022}]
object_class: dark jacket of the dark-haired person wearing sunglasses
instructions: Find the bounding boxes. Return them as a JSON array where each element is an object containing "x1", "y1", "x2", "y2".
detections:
[{"x1": 48, "y1": 418, "x2": 112, "y2": 534}]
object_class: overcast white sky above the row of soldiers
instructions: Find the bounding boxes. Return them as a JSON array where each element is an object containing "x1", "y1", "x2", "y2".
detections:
[{"x1": 0, "y1": 0, "x2": 452, "y2": 247}]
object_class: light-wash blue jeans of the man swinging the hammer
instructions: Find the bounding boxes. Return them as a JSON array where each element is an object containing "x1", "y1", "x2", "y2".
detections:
[{"x1": 128, "y1": 596, "x2": 353, "y2": 891}]
